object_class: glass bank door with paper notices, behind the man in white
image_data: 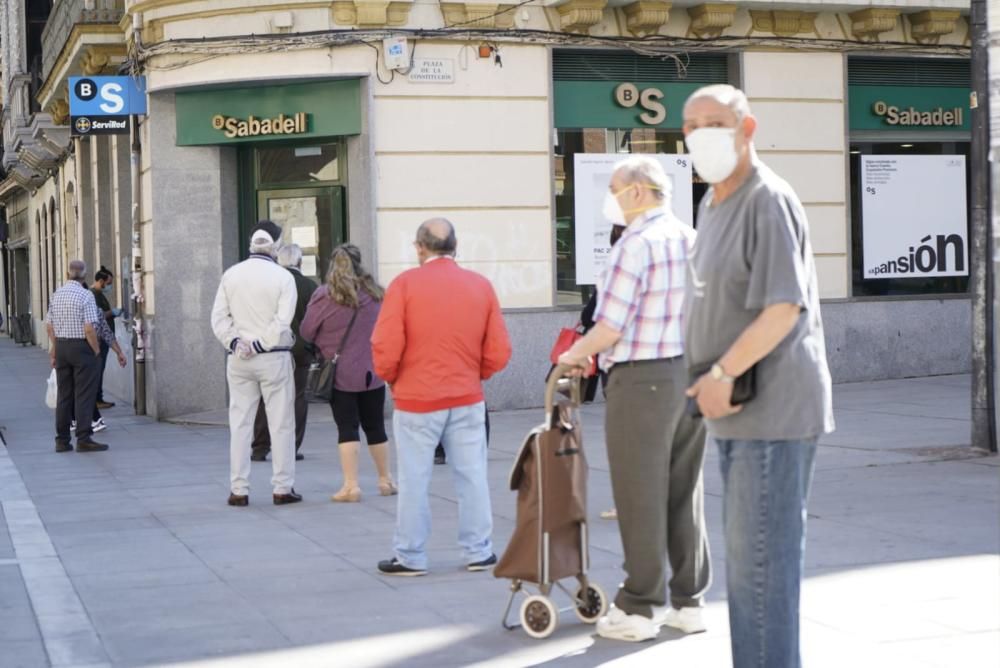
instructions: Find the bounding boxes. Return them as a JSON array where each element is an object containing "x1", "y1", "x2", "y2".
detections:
[{"x1": 257, "y1": 186, "x2": 344, "y2": 283}]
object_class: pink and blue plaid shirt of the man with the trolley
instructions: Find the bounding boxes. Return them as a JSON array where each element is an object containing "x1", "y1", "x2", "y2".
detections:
[{"x1": 594, "y1": 209, "x2": 695, "y2": 369}]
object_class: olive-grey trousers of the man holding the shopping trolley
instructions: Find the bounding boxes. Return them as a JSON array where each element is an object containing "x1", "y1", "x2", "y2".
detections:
[{"x1": 605, "y1": 358, "x2": 711, "y2": 617}]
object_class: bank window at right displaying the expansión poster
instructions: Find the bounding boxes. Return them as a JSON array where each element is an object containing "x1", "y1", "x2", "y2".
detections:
[{"x1": 850, "y1": 140, "x2": 971, "y2": 297}]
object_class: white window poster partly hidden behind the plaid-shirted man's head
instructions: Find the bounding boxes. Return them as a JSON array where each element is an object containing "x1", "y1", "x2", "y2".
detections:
[{"x1": 573, "y1": 153, "x2": 694, "y2": 285}]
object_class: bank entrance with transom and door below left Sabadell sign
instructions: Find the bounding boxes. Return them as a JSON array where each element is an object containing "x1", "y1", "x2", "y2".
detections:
[{"x1": 240, "y1": 142, "x2": 348, "y2": 283}]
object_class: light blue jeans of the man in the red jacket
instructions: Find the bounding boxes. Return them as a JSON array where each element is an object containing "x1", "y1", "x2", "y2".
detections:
[{"x1": 392, "y1": 402, "x2": 493, "y2": 570}]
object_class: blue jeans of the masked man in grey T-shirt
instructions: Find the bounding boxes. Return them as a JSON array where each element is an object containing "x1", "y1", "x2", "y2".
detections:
[{"x1": 714, "y1": 439, "x2": 816, "y2": 668}]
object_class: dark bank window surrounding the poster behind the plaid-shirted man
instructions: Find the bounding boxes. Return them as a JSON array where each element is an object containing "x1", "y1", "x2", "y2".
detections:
[{"x1": 555, "y1": 128, "x2": 708, "y2": 304}]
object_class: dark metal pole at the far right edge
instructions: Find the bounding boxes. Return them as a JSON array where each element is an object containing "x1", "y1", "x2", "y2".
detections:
[{"x1": 969, "y1": 0, "x2": 997, "y2": 450}]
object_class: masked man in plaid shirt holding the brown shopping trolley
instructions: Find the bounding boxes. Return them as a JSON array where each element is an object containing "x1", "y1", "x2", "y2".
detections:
[{"x1": 560, "y1": 156, "x2": 711, "y2": 642}]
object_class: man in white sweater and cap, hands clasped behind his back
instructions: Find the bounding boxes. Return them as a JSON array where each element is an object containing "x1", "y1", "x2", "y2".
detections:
[{"x1": 212, "y1": 220, "x2": 302, "y2": 506}]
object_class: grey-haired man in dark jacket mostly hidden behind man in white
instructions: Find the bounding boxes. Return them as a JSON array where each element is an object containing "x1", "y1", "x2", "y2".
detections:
[{"x1": 250, "y1": 244, "x2": 317, "y2": 462}]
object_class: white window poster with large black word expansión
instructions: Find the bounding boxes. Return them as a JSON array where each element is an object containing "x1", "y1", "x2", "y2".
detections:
[{"x1": 861, "y1": 155, "x2": 969, "y2": 279}]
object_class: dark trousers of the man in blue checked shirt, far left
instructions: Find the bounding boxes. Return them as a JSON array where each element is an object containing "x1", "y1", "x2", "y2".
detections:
[{"x1": 56, "y1": 339, "x2": 100, "y2": 443}]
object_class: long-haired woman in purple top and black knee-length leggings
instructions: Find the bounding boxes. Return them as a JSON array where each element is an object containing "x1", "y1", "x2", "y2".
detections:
[{"x1": 299, "y1": 244, "x2": 396, "y2": 503}]
